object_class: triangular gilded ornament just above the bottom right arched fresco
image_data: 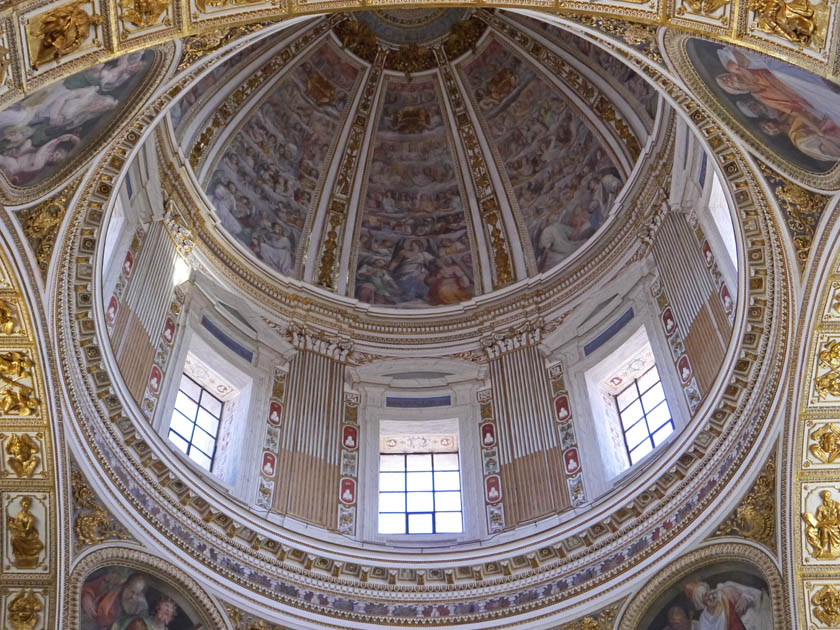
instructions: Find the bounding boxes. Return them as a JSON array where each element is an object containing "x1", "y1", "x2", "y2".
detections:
[{"x1": 714, "y1": 454, "x2": 776, "y2": 548}]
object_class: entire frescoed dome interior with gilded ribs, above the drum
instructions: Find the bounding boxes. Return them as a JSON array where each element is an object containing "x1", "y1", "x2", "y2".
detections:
[{"x1": 171, "y1": 9, "x2": 658, "y2": 308}]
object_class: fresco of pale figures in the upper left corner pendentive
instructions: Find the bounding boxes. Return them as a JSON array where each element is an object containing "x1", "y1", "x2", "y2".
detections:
[{"x1": 0, "y1": 50, "x2": 155, "y2": 187}]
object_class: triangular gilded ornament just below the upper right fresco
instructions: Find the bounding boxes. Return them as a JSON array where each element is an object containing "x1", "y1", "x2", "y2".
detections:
[{"x1": 758, "y1": 162, "x2": 829, "y2": 271}]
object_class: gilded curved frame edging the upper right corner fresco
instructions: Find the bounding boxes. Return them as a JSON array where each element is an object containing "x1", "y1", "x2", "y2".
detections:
[{"x1": 663, "y1": 31, "x2": 840, "y2": 191}]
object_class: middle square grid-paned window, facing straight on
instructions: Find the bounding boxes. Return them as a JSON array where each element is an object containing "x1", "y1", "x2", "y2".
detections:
[{"x1": 379, "y1": 452, "x2": 464, "y2": 534}]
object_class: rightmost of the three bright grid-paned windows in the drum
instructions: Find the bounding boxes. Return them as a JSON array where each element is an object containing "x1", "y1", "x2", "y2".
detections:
[{"x1": 615, "y1": 365, "x2": 674, "y2": 465}]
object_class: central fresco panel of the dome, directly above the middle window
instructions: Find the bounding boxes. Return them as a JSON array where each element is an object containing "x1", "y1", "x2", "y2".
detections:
[{"x1": 355, "y1": 79, "x2": 475, "y2": 307}]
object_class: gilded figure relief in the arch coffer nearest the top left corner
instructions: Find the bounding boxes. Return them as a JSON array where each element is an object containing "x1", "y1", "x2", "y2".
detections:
[{"x1": 27, "y1": 0, "x2": 105, "y2": 69}]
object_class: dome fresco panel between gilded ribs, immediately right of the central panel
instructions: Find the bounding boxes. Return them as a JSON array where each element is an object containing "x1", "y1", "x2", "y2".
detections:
[{"x1": 461, "y1": 40, "x2": 624, "y2": 271}]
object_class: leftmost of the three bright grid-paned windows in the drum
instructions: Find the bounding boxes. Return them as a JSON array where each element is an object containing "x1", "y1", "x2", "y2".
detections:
[{"x1": 169, "y1": 374, "x2": 224, "y2": 471}]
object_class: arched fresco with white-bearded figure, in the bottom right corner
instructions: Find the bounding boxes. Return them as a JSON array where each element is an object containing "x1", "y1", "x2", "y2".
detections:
[{"x1": 639, "y1": 562, "x2": 773, "y2": 630}]
